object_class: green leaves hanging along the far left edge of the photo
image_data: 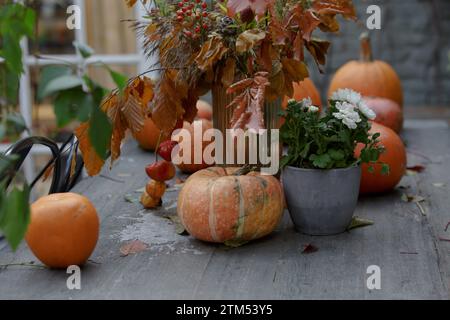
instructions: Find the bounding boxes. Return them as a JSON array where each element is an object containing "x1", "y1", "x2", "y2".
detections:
[{"x1": 0, "y1": 1, "x2": 36, "y2": 249}]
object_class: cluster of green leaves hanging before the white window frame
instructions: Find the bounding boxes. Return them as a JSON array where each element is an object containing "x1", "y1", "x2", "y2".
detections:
[{"x1": 37, "y1": 43, "x2": 128, "y2": 159}]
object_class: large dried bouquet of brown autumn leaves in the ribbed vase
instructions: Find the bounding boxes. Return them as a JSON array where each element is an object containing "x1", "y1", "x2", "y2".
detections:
[{"x1": 78, "y1": 0, "x2": 356, "y2": 173}]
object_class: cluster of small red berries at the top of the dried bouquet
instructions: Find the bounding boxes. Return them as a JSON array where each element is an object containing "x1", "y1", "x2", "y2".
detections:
[{"x1": 177, "y1": 0, "x2": 209, "y2": 38}]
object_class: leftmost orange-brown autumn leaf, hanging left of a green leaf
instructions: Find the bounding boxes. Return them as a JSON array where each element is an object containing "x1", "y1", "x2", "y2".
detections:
[{"x1": 75, "y1": 122, "x2": 105, "y2": 176}]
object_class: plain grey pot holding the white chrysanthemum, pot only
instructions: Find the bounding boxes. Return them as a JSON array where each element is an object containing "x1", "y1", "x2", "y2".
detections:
[{"x1": 282, "y1": 166, "x2": 361, "y2": 236}]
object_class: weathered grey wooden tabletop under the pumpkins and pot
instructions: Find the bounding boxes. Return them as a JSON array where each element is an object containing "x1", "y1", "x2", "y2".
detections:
[{"x1": 0, "y1": 120, "x2": 450, "y2": 299}]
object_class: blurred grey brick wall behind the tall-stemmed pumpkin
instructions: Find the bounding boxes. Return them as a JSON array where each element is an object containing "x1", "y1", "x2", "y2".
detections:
[{"x1": 309, "y1": 0, "x2": 450, "y2": 107}]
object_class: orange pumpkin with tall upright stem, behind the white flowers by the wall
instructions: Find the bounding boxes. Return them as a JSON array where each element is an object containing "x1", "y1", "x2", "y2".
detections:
[{"x1": 328, "y1": 34, "x2": 403, "y2": 108}]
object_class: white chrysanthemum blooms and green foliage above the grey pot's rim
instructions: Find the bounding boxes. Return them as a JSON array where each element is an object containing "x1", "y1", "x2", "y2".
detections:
[{"x1": 280, "y1": 90, "x2": 389, "y2": 173}]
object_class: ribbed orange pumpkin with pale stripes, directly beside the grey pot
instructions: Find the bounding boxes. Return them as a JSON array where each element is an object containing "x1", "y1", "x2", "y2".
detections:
[{"x1": 177, "y1": 167, "x2": 284, "y2": 243}]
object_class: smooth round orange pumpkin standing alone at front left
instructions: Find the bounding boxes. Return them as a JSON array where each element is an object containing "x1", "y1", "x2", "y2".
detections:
[{"x1": 25, "y1": 193, "x2": 99, "y2": 268}]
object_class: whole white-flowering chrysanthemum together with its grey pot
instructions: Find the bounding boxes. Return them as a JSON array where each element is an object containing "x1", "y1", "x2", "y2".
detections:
[{"x1": 280, "y1": 89, "x2": 389, "y2": 235}]
